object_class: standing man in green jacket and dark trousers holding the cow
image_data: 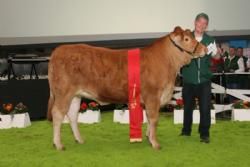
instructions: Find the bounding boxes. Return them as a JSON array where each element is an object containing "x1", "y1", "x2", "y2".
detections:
[{"x1": 181, "y1": 13, "x2": 217, "y2": 143}]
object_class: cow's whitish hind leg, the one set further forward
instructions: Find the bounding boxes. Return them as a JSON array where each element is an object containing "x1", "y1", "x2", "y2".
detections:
[{"x1": 67, "y1": 97, "x2": 83, "y2": 144}]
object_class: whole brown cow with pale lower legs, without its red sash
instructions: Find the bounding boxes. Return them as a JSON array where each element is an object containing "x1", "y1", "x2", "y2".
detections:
[{"x1": 48, "y1": 27, "x2": 207, "y2": 150}]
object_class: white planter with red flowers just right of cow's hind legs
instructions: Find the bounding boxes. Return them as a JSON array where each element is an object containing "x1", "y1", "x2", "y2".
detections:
[{"x1": 78, "y1": 102, "x2": 101, "y2": 124}]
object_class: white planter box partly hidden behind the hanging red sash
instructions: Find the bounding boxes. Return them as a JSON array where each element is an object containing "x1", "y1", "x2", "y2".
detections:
[{"x1": 113, "y1": 104, "x2": 147, "y2": 124}]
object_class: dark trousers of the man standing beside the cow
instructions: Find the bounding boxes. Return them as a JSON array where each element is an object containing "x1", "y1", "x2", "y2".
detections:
[{"x1": 182, "y1": 82, "x2": 211, "y2": 137}]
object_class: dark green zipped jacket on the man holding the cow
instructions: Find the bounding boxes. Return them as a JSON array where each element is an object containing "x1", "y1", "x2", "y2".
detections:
[{"x1": 181, "y1": 33, "x2": 215, "y2": 84}]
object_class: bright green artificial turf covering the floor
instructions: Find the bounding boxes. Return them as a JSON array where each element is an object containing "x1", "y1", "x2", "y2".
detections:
[{"x1": 0, "y1": 112, "x2": 250, "y2": 167}]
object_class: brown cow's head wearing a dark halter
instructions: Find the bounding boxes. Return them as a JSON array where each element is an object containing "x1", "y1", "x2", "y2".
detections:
[{"x1": 169, "y1": 27, "x2": 207, "y2": 58}]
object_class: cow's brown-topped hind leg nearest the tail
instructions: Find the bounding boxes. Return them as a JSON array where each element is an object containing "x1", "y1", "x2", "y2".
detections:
[{"x1": 52, "y1": 96, "x2": 70, "y2": 150}]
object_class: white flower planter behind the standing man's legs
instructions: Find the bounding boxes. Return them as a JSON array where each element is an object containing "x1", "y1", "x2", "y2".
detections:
[{"x1": 174, "y1": 99, "x2": 216, "y2": 124}]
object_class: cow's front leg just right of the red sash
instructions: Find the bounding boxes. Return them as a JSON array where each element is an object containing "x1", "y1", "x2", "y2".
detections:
[{"x1": 146, "y1": 99, "x2": 160, "y2": 149}]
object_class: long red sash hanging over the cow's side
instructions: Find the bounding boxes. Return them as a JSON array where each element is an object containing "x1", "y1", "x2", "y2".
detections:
[{"x1": 128, "y1": 49, "x2": 143, "y2": 142}]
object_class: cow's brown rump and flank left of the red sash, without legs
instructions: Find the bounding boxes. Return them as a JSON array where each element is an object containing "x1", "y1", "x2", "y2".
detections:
[{"x1": 48, "y1": 44, "x2": 131, "y2": 102}]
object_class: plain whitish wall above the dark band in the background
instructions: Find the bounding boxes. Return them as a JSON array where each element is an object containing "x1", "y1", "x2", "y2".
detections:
[{"x1": 0, "y1": 0, "x2": 250, "y2": 38}]
